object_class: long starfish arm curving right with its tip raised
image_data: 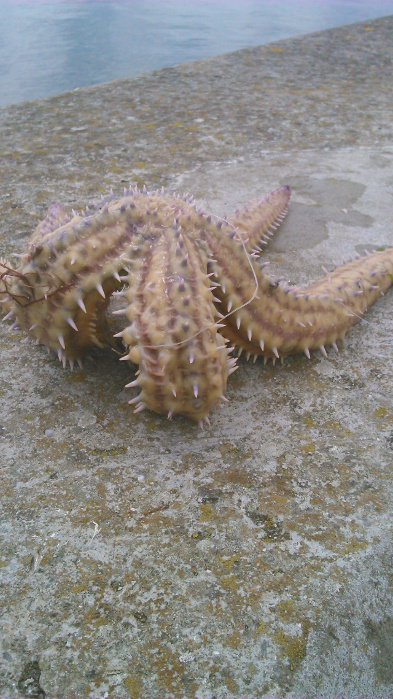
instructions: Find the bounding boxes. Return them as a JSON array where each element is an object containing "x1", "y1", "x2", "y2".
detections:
[{"x1": 204, "y1": 231, "x2": 393, "y2": 357}]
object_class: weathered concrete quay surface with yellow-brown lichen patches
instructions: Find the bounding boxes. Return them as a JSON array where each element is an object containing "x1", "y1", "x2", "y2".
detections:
[{"x1": 0, "y1": 12, "x2": 393, "y2": 699}]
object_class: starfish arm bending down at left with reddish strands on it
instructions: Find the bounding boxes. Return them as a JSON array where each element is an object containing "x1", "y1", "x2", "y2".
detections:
[{"x1": 0, "y1": 202, "x2": 154, "y2": 363}]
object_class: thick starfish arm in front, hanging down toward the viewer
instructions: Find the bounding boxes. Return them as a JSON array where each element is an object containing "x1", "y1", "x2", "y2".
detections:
[{"x1": 120, "y1": 228, "x2": 231, "y2": 422}]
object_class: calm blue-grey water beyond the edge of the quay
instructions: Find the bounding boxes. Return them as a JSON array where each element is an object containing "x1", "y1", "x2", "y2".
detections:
[{"x1": 0, "y1": 0, "x2": 393, "y2": 106}]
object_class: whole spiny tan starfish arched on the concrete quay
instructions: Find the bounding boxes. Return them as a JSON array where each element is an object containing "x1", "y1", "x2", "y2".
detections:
[{"x1": 0, "y1": 187, "x2": 393, "y2": 424}]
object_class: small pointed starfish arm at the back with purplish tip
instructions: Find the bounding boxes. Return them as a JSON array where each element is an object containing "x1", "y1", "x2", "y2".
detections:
[{"x1": 228, "y1": 185, "x2": 291, "y2": 257}]
